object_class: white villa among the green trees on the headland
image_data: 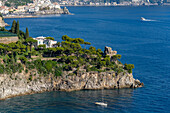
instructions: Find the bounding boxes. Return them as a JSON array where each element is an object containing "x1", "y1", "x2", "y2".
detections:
[{"x1": 34, "y1": 36, "x2": 57, "y2": 48}]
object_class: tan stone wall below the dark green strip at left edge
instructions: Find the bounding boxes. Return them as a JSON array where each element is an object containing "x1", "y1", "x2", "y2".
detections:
[{"x1": 0, "y1": 36, "x2": 18, "y2": 44}]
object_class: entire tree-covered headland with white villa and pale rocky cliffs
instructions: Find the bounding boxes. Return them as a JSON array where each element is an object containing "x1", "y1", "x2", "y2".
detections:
[{"x1": 0, "y1": 21, "x2": 144, "y2": 100}]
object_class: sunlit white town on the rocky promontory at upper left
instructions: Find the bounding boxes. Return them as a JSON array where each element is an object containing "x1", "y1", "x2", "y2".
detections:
[{"x1": 0, "y1": 0, "x2": 69, "y2": 18}]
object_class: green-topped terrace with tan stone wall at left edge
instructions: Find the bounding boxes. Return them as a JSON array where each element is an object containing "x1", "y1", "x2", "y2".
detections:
[{"x1": 0, "y1": 31, "x2": 18, "y2": 44}]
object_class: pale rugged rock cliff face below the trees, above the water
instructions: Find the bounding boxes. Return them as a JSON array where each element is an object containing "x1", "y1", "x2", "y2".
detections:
[{"x1": 0, "y1": 72, "x2": 143, "y2": 99}]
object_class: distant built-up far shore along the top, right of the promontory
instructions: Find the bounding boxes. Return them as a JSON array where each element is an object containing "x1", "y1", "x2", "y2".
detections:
[{"x1": 52, "y1": 0, "x2": 170, "y2": 6}]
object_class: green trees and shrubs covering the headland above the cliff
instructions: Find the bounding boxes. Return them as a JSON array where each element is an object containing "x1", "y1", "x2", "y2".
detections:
[{"x1": 0, "y1": 21, "x2": 134, "y2": 80}]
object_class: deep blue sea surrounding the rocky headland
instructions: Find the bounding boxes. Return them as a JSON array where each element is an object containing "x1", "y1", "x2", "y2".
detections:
[{"x1": 0, "y1": 6, "x2": 170, "y2": 113}]
